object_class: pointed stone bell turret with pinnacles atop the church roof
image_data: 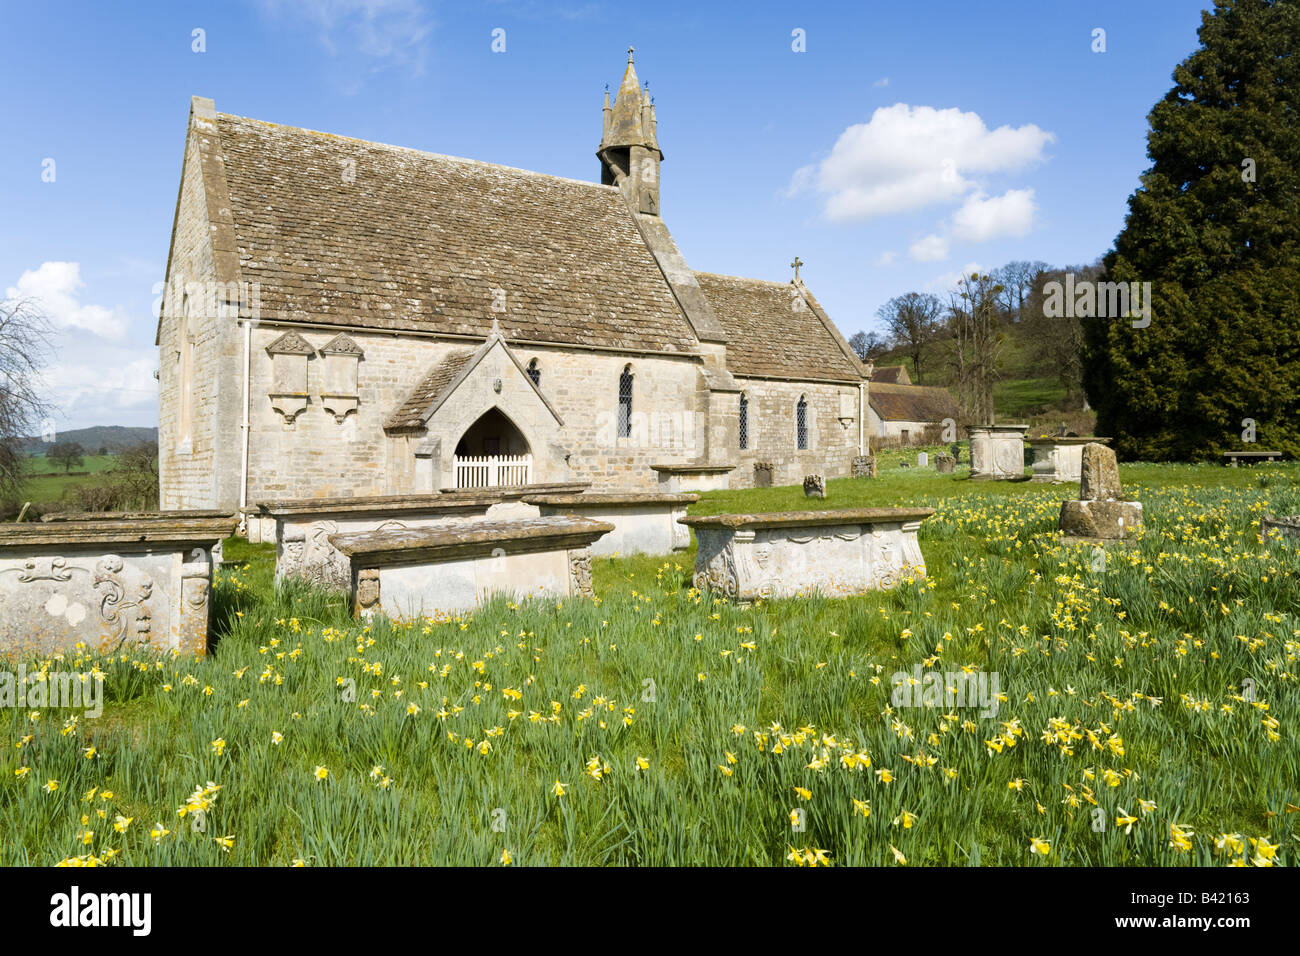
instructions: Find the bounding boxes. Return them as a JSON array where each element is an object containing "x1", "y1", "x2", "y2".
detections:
[{"x1": 595, "y1": 47, "x2": 663, "y2": 216}]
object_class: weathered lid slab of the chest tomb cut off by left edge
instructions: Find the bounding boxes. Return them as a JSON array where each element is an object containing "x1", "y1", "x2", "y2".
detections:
[{"x1": 0, "y1": 512, "x2": 238, "y2": 553}]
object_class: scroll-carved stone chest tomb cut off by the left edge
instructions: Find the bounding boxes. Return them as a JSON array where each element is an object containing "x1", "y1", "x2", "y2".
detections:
[{"x1": 0, "y1": 512, "x2": 237, "y2": 654}]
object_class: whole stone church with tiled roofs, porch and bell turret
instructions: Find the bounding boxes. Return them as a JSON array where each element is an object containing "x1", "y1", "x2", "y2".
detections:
[{"x1": 156, "y1": 51, "x2": 870, "y2": 511}]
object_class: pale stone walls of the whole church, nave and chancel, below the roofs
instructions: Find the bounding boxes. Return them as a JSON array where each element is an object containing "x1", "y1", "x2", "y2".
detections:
[{"x1": 170, "y1": 319, "x2": 858, "y2": 509}]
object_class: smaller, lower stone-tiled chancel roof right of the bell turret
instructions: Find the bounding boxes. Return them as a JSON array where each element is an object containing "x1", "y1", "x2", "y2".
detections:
[{"x1": 696, "y1": 272, "x2": 863, "y2": 385}]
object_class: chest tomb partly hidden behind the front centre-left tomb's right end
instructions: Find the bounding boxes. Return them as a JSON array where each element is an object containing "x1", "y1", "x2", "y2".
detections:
[{"x1": 523, "y1": 492, "x2": 699, "y2": 554}]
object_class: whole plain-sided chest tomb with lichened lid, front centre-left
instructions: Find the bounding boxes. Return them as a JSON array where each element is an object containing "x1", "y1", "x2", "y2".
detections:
[{"x1": 329, "y1": 515, "x2": 614, "y2": 620}]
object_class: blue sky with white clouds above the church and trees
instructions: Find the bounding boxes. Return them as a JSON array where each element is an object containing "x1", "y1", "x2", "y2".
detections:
[{"x1": 0, "y1": 0, "x2": 1208, "y2": 429}]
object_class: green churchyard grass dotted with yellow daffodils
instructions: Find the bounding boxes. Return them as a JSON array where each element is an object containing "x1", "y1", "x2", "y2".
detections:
[{"x1": 0, "y1": 462, "x2": 1300, "y2": 866}]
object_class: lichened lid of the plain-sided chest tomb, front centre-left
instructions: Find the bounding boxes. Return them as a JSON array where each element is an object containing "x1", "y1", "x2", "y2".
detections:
[{"x1": 329, "y1": 515, "x2": 614, "y2": 567}]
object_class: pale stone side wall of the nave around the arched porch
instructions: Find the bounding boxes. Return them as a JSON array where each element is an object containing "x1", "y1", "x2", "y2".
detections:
[{"x1": 239, "y1": 325, "x2": 701, "y2": 501}]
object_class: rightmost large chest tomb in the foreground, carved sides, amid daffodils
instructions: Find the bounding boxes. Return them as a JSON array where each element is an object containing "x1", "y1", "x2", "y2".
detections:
[{"x1": 681, "y1": 507, "x2": 935, "y2": 601}]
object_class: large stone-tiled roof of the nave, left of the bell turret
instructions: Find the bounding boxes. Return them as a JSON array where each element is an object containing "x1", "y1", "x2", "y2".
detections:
[{"x1": 215, "y1": 113, "x2": 698, "y2": 354}]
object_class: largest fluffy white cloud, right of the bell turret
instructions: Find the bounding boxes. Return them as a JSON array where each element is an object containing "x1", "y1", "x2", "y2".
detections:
[{"x1": 790, "y1": 103, "x2": 1056, "y2": 221}]
